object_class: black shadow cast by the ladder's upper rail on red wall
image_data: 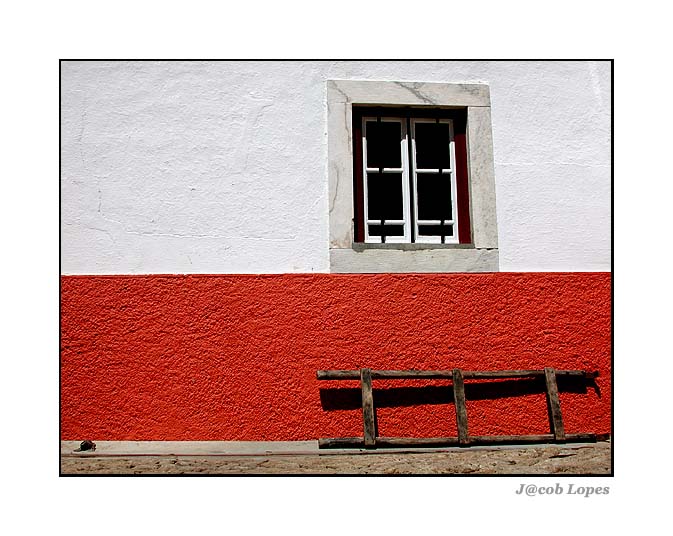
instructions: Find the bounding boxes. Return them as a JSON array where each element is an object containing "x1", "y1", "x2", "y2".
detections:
[{"x1": 320, "y1": 377, "x2": 601, "y2": 411}]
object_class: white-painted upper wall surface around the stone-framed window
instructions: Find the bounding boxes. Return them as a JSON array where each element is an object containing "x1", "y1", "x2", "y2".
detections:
[{"x1": 61, "y1": 62, "x2": 610, "y2": 274}]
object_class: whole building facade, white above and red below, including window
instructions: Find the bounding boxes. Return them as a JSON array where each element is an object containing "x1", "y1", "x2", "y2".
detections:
[{"x1": 61, "y1": 61, "x2": 611, "y2": 441}]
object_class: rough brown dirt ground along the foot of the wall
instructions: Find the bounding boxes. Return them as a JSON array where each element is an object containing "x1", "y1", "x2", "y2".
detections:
[{"x1": 61, "y1": 441, "x2": 611, "y2": 475}]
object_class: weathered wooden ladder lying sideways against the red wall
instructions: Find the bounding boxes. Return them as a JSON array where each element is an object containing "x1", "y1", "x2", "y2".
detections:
[{"x1": 317, "y1": 367, "x2": 609, "y2": 449}]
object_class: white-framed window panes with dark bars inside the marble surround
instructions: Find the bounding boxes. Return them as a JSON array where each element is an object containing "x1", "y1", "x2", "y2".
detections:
[{"x1": 353, "y1": 107, "x2": 471, "y2": 244}]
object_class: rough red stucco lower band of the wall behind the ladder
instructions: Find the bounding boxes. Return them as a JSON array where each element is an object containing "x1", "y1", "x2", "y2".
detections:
[{"x1": 61, "y1": 273, "x2": 611, "y2": 440}]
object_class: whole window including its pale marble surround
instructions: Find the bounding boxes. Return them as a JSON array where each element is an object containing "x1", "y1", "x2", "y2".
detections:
[{"x1": 326, "y1": 80, "x2": 499, "y2": 273}]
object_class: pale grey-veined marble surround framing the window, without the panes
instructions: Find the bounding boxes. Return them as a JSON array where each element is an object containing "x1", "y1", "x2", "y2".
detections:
[{"x1": 327, "y1": 80, "x2": 498, "y2": 273}]
